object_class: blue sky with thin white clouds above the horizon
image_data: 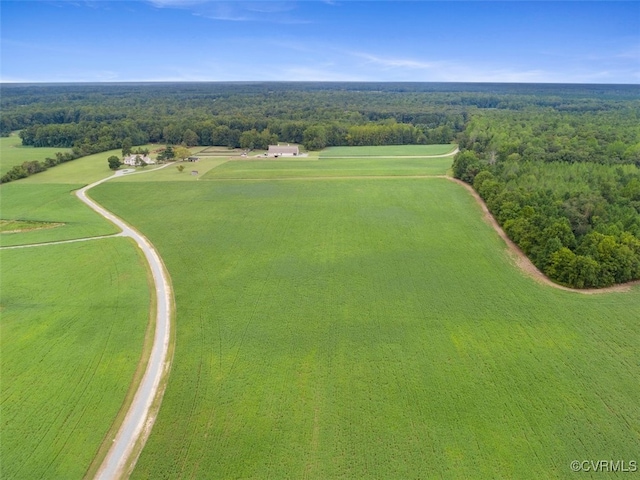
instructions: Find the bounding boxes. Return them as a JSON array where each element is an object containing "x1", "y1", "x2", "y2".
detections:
[{"x1": 0, "y1": 0, "x2": 640, "y2": 84}]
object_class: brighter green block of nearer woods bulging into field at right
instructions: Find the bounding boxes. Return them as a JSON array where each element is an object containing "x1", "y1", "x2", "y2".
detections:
[{"x1": 453, "y1": 108, "x2": 640, "y2": 288}]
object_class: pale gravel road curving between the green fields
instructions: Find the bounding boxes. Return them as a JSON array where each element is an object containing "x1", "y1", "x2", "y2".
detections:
[{"x1": 67, "y1": 162, "x2": 174, "y2": 480}]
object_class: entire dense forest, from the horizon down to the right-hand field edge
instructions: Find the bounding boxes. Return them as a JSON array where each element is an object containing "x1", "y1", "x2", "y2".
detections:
[{"x1": 0, "y1": 83, "x2": 640, "y2": 288}]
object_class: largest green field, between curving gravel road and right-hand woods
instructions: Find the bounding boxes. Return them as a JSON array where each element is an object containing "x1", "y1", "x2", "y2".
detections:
[{"x1": 93, "y1": 144, "x2": 640, "y2": 479}]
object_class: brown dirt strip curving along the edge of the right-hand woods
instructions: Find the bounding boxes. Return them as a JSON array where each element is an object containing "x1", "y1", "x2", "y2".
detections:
[{"x1": 443, "y1": 176, "x2": 640, "y2": 295}]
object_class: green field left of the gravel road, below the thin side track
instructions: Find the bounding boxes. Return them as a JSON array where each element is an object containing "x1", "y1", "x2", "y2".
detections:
[{"x1": 0, "y1": 238, "x2": 150, "y2": 479}]
